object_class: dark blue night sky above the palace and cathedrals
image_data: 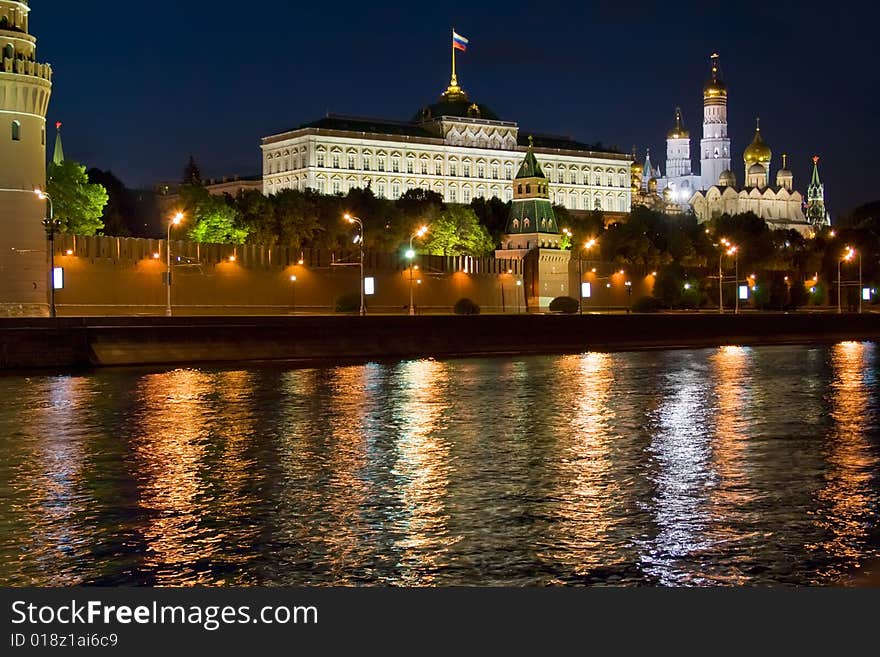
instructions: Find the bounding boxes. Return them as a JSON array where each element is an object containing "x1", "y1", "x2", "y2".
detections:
[{"x1": 31, "y1": 0, "x2": 880, "y2": 214}]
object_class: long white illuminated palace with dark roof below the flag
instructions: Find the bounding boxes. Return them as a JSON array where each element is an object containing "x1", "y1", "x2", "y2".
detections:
[{"x1": 262, "y1": 69, "x2": 632, "y2": 213}]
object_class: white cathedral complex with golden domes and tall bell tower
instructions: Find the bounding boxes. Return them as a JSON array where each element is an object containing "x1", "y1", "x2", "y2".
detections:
[{"x1": 633, "y1": 54, "x2": 830, "y2": 235}]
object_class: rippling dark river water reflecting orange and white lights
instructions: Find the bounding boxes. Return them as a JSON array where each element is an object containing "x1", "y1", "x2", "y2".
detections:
[{"x1": 0, "y1": 343, "x2": 880, "y2": 586}]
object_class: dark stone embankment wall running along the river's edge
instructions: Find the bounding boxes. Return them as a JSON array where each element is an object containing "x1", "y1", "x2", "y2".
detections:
[{"x1": 0, "y1": 313, "x2": 880, "y2": 370}]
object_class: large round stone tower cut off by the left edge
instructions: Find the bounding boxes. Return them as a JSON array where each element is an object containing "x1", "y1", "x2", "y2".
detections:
[{"x1": 0, "y1": 0, "x2": 52, "y2": 315}]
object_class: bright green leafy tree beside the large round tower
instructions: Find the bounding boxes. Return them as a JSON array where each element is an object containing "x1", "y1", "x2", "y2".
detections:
[{"x1": 46, "y1": 160, "x2": 108, "y2": 236}]
